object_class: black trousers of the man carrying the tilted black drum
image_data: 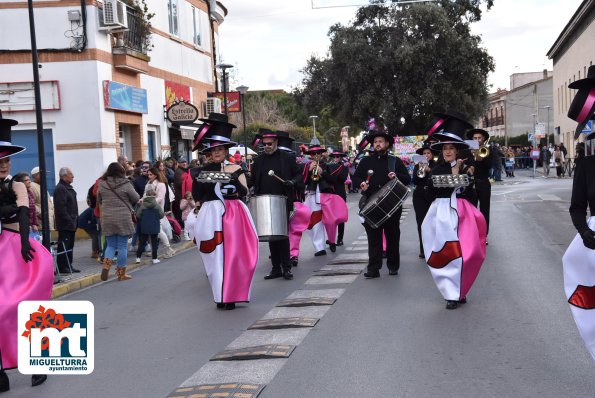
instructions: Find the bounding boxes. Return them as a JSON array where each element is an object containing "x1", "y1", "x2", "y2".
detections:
[{"x1": 364, "y1": 207, "x2": 403, "y2": 271}]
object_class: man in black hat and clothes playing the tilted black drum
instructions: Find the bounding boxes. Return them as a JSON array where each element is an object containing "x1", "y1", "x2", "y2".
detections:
[{"x1": 353, "y1": 130, "x2": 411, "y2": 278}]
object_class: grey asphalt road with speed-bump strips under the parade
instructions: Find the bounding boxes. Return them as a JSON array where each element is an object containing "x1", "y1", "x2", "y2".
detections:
[{"x1": 6, "y1": 171, "x2": 595, "y2": 397}]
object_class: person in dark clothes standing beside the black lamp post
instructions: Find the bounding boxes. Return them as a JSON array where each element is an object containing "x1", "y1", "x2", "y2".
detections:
[{"x1": 54, "y1": 167, "x2": 81, "y2": 273}]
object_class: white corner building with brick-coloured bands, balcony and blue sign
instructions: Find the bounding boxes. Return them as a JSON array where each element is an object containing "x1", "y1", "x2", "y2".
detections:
[{"x1": 0, "y1": 0, "x2": 227, "y2": 196}]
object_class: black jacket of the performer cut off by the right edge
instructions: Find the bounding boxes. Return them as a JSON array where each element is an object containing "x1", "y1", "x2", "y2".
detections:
[{"x1": 569, "y1": 156, "x2": 595, "y2": 234}]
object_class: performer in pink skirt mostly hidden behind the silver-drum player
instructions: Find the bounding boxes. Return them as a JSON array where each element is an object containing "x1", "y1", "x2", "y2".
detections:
[{"x1": 276, "y1": 131, "x2": 312, "y2": 267}]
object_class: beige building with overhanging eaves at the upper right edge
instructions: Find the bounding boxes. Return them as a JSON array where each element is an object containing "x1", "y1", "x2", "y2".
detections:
[{"x1": 547, "y1": 0, "x2": 595, "y2": 156}]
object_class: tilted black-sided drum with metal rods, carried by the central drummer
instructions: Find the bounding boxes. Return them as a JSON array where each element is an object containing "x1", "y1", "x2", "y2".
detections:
[{"x1": 359, "y1": 178, "x2": 410, "y2": 228}]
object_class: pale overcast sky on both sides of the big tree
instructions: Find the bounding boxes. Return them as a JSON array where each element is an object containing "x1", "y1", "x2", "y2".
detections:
[{"x1": 219, "y1": 0, "x2": 582, "y2": 92}]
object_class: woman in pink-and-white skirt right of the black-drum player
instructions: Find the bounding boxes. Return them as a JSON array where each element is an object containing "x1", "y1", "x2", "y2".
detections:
[{"x1": 422, "y1": 113, "x2": 486, "y2": 310}]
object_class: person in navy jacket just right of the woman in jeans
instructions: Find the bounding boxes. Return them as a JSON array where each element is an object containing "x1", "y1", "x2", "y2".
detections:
[{"x1": 136, "y1": 185, "x2": 165, "y2": 264}]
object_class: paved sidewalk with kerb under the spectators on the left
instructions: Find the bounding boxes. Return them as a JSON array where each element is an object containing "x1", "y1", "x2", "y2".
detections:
[{"x1": 52, "y1": 239, "x2": 195, "y2": 299}]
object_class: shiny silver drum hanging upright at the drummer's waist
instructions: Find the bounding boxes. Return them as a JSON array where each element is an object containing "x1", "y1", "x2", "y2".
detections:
[{"x1": 248, "y1": 195, "x2": 287, "y2": 242}]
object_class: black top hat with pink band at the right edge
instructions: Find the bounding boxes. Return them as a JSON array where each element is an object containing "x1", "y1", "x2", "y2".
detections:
[{"x1": 568, "y1": 65, "x2": 595, "y2": 140}]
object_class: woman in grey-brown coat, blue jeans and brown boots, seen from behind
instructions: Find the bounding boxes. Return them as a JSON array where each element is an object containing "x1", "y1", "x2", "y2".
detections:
[{"x1": 97, "y1": 162, "x2": 140, "y2": 281}]
